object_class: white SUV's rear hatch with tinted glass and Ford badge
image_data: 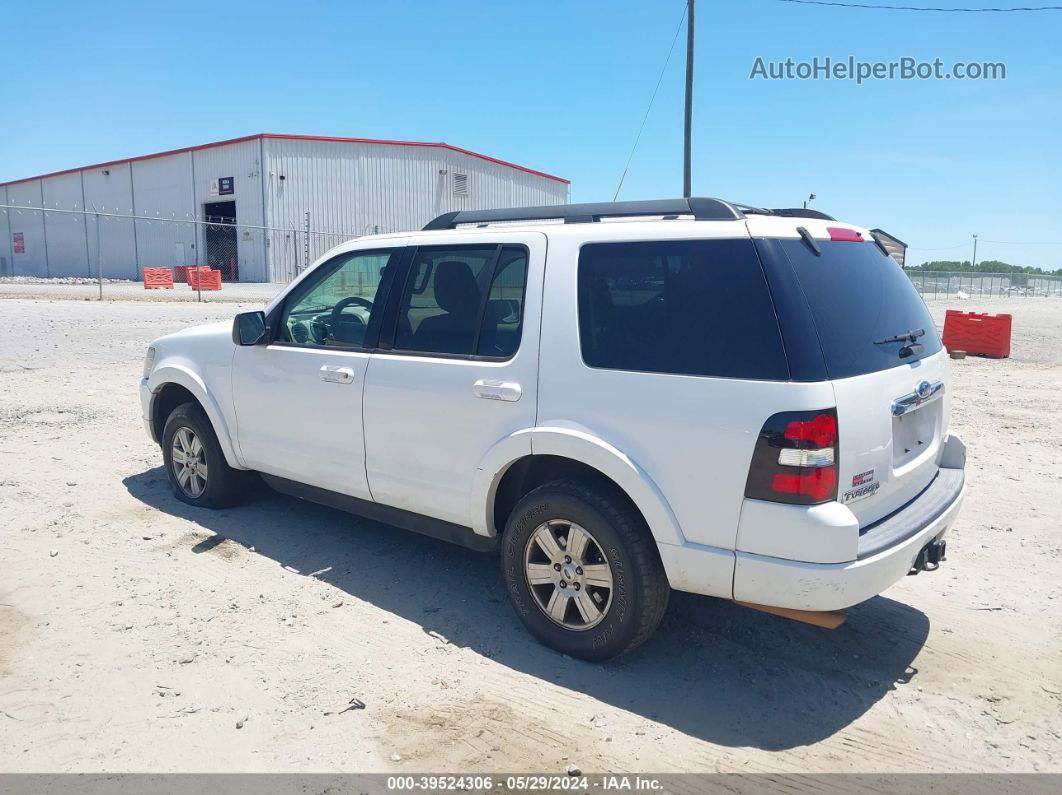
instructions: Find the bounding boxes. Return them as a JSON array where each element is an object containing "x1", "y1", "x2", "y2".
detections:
[{"x1": 757, "y1": 221, "x2": 949, "y2": 526}]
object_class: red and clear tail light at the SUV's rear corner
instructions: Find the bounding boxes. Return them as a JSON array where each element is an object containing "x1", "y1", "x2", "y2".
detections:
[{"x1": 744, "y1": 409, "x2": 837, "y2": 505}]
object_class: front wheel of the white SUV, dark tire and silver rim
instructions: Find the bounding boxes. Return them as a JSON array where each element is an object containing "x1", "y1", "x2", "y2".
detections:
[{"x1": 162, "y1": 402, "x2": 252, "y2": 508}]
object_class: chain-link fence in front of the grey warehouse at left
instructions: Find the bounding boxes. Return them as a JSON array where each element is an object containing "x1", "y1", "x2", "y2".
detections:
[{"x1": 0, "y1": 204, "x2": 367, "y2": 282}]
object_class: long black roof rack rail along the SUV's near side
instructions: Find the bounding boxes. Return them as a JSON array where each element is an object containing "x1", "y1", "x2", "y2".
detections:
[{"x1": 424, "y1": 197, "x2": 744, "y2": 231}]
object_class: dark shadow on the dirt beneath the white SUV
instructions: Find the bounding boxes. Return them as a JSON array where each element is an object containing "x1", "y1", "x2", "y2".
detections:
[{"x1": 124, "y1": 467, "x2": 929, "y2": 750}]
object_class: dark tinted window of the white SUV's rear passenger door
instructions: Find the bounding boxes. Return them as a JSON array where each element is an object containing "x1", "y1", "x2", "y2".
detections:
[{"x1": 394, "y1": 245, "x2": 527, "y2": 357}]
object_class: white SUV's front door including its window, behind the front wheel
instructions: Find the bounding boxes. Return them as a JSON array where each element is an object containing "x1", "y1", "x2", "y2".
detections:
[{"x1": 233, "y1": 244, "x2": 405, "y2": 499}]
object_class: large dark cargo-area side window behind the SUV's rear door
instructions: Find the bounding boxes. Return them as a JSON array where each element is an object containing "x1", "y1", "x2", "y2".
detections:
[{"x1": 579, "y1": 240, "x2": 789, "y2": 381}]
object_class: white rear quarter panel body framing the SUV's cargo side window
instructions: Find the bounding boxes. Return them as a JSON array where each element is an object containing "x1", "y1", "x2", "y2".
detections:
[{"x1": 537, "y1": 222, "x2": 834, "y2": 551}]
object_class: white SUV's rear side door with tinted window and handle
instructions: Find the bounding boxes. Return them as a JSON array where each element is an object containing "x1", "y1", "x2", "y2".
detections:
[{"x1": 364, "y1": 230, "x2": 546, "y2": 526}]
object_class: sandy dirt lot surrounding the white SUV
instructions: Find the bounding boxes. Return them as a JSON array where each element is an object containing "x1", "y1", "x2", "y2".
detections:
[{"x1": 0, "y1": 292, "x2": 1062, "y2": 773}]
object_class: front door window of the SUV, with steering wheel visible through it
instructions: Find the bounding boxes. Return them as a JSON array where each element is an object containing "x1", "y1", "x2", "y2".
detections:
[{"x1": 277, "y1": 249, "x2": 400, "y2": 347}]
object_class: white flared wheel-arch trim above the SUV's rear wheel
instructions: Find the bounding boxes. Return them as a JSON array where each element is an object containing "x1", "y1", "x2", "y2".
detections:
[{"x1": 472, "y1": 427, "x2": 685, "y2": 545}]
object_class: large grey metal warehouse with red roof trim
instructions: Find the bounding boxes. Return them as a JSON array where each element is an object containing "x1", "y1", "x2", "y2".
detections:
[{"x1": 0, "y1": 133, "x2": 568, "y2": 281}]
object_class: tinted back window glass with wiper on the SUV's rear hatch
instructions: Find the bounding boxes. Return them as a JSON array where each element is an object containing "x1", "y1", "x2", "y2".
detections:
[{"x1": 778, "y1": 240, "x2": 941, "y2": 379}]
